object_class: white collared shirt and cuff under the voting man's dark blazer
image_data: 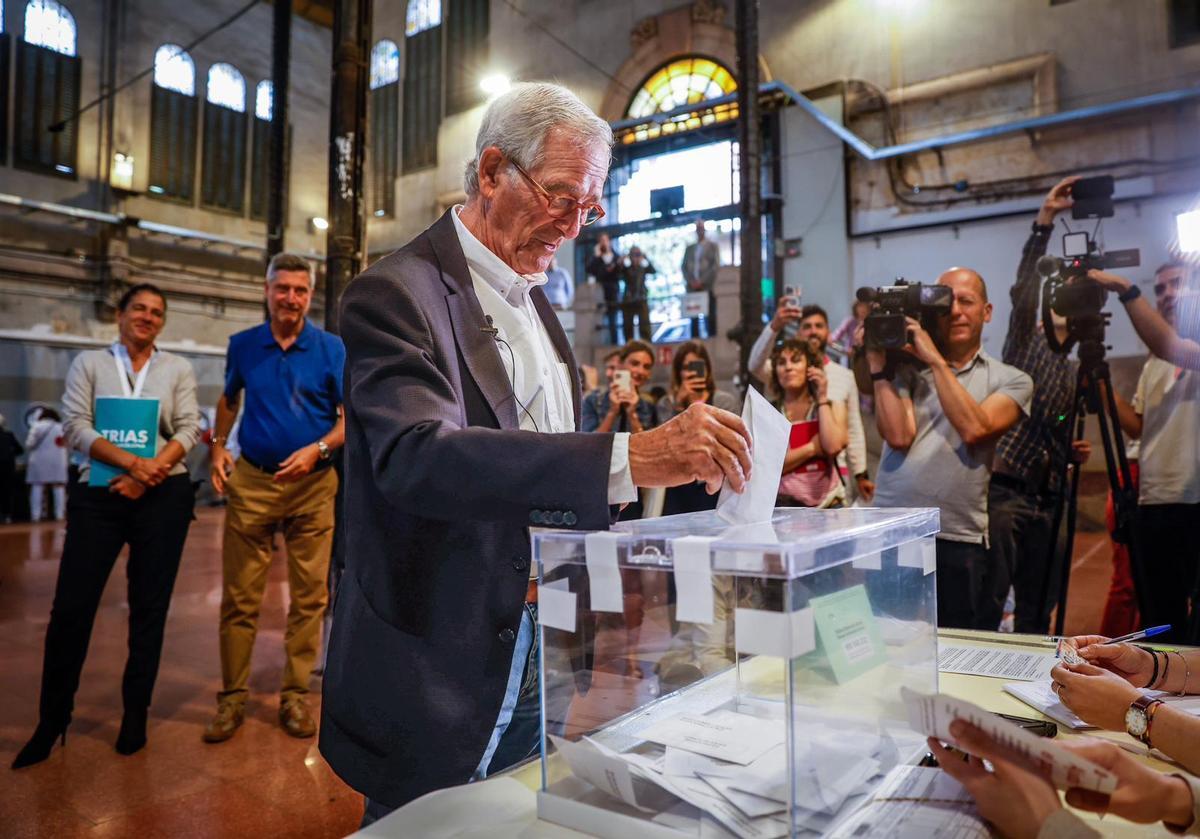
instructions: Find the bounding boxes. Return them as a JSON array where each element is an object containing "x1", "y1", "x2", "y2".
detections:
[{"x1": 451, "y1": 205, "x2": 637, "y2": 504}]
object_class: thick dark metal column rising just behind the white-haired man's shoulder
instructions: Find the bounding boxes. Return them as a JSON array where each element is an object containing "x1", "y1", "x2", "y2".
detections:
[{"x1": 325, "y1": 0, "x2": 372, "y2": 335}]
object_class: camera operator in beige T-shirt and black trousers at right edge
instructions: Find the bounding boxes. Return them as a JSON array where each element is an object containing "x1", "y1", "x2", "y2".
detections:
[{"x1": 1090, "y1": 263, "x2": 1200, "y2": 643}]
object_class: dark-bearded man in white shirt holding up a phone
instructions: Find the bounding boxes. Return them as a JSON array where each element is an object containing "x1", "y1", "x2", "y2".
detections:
[{"x1": 749, "y1": 296, "x2": 875, "y2": 503}]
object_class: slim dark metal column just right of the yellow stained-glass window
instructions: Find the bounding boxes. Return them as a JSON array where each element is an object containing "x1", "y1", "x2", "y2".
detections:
[{"x1": 736, "y1": 0, "x2": 762, "y2": 386}]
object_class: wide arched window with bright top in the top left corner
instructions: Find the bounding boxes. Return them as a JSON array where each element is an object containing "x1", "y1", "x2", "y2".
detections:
[{"x1": 13, "y1": 0, "x2": 79, "y2": 178}]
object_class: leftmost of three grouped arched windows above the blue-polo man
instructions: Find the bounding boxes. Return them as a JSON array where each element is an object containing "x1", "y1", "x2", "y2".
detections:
[{"x1": 148, "y1": 43, "x2": 198, "y2": 203}]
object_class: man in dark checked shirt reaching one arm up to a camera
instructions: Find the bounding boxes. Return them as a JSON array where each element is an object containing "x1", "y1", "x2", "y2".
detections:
[{"x1": 979, "y1": 176, "x2": 1088, "y2": 633}]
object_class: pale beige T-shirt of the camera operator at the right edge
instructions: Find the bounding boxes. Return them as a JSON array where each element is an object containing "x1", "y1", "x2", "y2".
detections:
[{"x1": 1133, "y1": 358, "x2": 1200, "y2": 504}]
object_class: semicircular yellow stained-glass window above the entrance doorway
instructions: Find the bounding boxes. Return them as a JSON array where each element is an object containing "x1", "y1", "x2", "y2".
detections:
[{"x1": 622, "y1": 56, "x2": 738, "y2": 143}]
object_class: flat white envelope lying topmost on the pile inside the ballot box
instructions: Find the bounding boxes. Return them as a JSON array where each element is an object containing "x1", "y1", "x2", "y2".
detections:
[{"x1": 638, "y1": 711, "x2": 784, "y2": 766}]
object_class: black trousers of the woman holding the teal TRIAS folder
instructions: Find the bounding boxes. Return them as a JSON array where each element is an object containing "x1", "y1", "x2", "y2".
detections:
[{"x1": 40, "y1": 475, "x2": 196, "y2": 724}]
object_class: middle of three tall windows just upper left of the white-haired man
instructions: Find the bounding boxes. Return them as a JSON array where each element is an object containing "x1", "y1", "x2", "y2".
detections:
[{"x1": 401, "y1": 0, "x2": 442, "y2": 172}]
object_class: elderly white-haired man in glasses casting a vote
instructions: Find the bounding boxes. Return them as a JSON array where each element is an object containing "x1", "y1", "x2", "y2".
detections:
[{"x1": 320, "y1": 84, "x2": 750, "y2": 823}]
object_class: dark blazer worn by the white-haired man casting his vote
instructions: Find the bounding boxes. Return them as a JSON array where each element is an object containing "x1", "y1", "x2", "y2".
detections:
[{"x1": 320, "y1": 212, "x2": 612, "y2": 807}]
